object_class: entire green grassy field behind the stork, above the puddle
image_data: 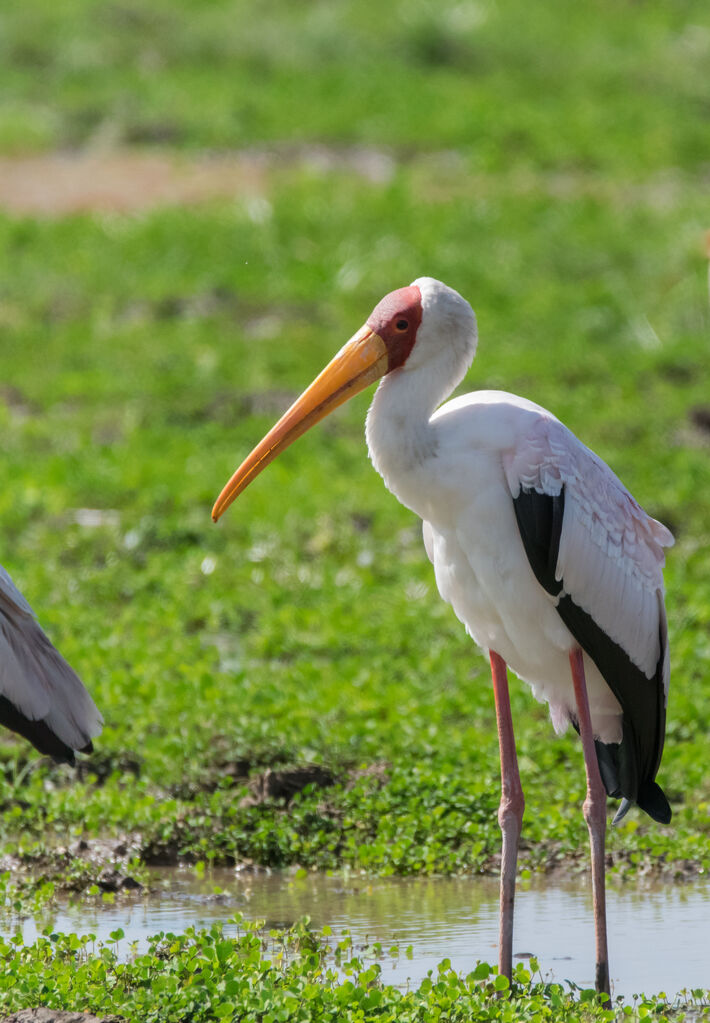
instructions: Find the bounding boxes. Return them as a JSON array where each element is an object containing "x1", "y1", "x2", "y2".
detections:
[{"x1": 0, "y1": 0, "x2": 710, "y2": 873}]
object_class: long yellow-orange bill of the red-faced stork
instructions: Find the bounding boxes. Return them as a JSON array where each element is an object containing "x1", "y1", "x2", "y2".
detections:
[{"x1": 212, "y1": 325, "x2": 388, "y2": 522}]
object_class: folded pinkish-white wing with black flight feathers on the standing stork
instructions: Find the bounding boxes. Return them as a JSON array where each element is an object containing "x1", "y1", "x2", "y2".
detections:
[{"x1": 504, "y1": 417, "x2": 673, "y2": 820}]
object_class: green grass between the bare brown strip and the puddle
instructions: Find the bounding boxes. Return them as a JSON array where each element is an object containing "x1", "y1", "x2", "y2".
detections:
[{"x1": 0, "y1": 170, "x2": 710, "y2": 873}]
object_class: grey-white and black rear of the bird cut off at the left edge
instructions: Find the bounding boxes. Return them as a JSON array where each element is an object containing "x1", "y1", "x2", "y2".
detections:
[{"x1": 0, "y1": 566, "x2": 103, "y2": 764}]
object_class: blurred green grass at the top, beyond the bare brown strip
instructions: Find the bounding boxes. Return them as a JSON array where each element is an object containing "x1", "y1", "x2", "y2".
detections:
[{"x1": 0, "y1": 0, "x2": 710, "y2": 178}]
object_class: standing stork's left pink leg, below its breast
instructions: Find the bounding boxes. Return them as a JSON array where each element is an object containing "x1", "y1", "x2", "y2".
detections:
[{"x1": 490, "y1": 651, "x2": 525, "y2": 980}]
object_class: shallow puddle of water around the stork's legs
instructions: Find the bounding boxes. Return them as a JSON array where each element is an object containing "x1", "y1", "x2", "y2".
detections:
[{"x1": 12, "y1": 870, "x2": 710, "y2": 997}]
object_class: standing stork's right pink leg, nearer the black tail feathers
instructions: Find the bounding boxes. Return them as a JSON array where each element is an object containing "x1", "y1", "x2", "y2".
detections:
[{"x1": 570, "y1": 647, "x2": 610, "y2": 994}]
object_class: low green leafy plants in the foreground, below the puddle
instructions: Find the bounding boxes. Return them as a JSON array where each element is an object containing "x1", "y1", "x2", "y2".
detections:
[{"x1": 0, "y1": 917, "x2": 707, "y2": 1023}]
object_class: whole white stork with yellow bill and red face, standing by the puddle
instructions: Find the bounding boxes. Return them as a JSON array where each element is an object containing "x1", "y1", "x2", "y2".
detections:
[{"x1": 213, "y1": 277, "x2": 673, "y2": 994}]
